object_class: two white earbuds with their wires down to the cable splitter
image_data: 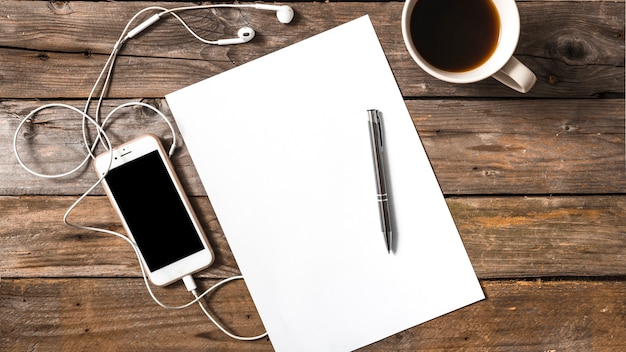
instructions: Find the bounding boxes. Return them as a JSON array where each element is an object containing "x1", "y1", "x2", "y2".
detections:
[{"x1": 124, "y1": 4, "x2": 294, "y2": 45}]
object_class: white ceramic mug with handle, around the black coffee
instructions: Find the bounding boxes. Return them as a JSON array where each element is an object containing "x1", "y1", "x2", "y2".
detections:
[{"x1": 402, "y1": 0, "x2": 537, "y2": 93}]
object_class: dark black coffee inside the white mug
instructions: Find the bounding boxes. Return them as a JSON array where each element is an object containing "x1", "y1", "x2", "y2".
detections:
[{"x1": 410, "y1": 0, "x2": 500, "y2": 72}]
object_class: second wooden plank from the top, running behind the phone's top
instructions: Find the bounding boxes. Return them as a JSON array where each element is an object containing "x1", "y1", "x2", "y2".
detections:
[{"x1": 0, "y1": 99, "x2": 626, "y2": 195}]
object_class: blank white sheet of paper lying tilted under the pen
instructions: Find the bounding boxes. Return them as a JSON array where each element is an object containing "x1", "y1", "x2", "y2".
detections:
[{"x1": 166, "y1": 16, "x2": 484, "y2": 351}]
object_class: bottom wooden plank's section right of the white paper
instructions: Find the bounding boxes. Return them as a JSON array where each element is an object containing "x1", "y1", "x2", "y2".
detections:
[{"x1": 363, "y1": 280, "x2": 626, "y2": 352}]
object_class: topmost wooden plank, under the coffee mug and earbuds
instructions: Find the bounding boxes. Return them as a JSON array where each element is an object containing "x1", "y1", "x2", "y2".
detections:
[{"x1": 0, "y1": 1, "x2": 624, "y2": 98}]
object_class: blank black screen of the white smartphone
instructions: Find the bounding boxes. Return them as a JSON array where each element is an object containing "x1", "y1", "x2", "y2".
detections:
[{"x1": 106, "y1": 151, "x2": 204, "y2": 271}]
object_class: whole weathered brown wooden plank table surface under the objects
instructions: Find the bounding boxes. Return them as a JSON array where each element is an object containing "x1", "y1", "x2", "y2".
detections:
[{"x1": 0, "y1": 0, "x2": 626, "y2": 351}]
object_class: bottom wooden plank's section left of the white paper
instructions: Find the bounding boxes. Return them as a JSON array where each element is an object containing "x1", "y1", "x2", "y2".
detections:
[{"x1": 0, "y1": 278, "x2": 272, "y2": 351}]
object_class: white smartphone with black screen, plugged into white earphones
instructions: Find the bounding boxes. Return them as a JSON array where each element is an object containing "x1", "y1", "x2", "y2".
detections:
[{"x1": 94, "y1": 134, "x2": 213, "y2": 286}]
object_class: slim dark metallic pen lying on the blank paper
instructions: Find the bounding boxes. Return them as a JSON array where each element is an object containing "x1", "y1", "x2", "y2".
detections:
[{"x1": 367, "y1": 109, "x2": 393, "y2": 253}]
